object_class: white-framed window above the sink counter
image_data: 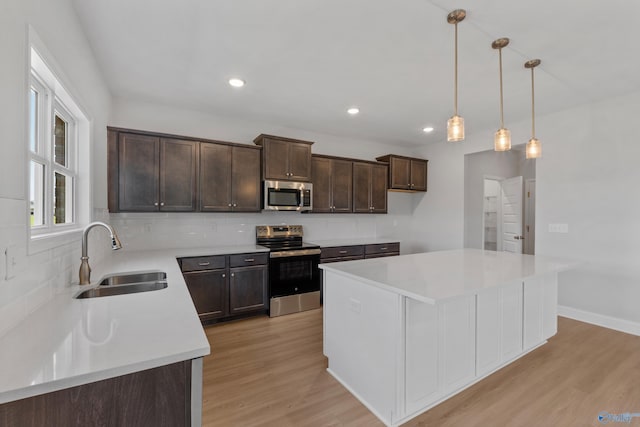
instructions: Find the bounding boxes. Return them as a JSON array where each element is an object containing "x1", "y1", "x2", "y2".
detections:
[{"x1": 27, "y1": 48, "x2": 88, "y2": 241}]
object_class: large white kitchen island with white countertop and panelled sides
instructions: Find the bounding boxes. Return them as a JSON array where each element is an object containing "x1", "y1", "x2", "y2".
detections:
[{"x1": 320, "y1": 249, "x2": 570, "y2": 426}]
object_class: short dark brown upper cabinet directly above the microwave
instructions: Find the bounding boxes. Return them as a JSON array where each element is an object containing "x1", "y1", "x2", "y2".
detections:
[{"x1": 253, "y1": 134, "x2": 313, "y2": 182}]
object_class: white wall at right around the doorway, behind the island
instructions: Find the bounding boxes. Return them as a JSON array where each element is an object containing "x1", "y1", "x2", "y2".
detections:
[{"x1": 413, "y1": 93, "x2": 640, "y2": 334}]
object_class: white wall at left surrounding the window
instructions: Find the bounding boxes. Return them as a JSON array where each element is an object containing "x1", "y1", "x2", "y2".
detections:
[{"x1": 0, "y1": 0, "x2": 110, "y2": 334}]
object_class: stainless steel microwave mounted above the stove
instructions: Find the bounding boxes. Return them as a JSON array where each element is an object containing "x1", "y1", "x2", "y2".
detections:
[{"x1": 264, "y1": 181, "x2": 313, "y2": 211}]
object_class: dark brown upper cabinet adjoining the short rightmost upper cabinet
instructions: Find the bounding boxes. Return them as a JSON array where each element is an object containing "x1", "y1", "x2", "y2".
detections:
[{"x1": 353, "y1": 161, "x2": 388, "y2": 213}]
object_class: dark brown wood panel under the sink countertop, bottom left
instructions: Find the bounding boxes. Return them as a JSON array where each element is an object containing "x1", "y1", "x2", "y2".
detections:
[{"x1": 0, "y1": 360, "x2": 191, "y2": 427}]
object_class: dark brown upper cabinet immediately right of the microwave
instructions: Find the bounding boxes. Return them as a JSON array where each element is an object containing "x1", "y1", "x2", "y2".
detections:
[{"x1": 311, "y1": 156, "x2": 353, "y2": 213}]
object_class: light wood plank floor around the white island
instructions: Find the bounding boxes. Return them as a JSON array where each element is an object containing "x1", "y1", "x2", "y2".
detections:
[{"x1": 203, "y1": 310, "x2": 640, "y2": 427}]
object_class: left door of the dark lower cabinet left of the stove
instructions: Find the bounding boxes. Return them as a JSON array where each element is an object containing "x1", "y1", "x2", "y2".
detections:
[{"x1": 184, "y1": 270, "x2": 229, "y2": 320}]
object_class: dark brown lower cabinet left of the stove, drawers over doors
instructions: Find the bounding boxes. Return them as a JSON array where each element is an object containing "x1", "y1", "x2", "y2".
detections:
[{"x1": 179, "y1": 252, "x2": 269, "y2": 324}]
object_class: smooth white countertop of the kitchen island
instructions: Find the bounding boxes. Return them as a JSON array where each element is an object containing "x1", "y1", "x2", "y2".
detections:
[{"x1": 320, "y1": 249, "x2": 573, "y2": 304}]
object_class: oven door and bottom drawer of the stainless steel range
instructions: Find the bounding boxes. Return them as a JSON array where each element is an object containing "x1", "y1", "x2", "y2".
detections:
[{"x1": 269, "y1": 251, "x2": 321, "y2": 317}]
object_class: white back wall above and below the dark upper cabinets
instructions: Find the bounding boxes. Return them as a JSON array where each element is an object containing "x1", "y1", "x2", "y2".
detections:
[{"x1": 109, "y1": 99, "x2": 420, "y2": 253}]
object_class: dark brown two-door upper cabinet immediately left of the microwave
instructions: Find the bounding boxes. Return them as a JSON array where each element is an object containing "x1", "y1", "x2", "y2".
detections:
[{"x1": 199, "y1": 143, "x2": 260, "y2": 212}]
